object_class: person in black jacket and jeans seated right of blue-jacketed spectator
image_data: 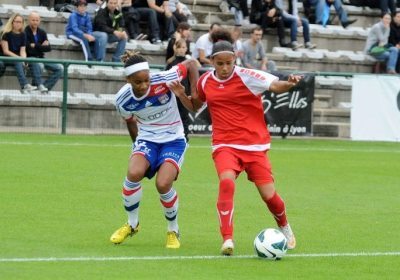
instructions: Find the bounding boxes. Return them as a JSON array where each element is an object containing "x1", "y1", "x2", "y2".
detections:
[{"x1": 94, "y1": 0, "x2": 128, "y2": 62}]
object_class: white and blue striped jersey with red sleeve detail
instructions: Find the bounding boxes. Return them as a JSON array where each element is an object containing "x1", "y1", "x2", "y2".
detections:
[{"x1": 115, "y1": 64, "x2": 187, "y2": 143}]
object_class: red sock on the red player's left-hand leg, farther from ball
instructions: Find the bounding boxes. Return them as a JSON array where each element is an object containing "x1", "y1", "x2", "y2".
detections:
[{"x1": 217, "y1": 179, "x2": 235, "y2": 240}]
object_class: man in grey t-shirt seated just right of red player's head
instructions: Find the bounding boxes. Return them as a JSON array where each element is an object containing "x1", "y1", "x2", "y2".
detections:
[{"x1": 243, "y1": 27, "x2": 276, "y2": 72}]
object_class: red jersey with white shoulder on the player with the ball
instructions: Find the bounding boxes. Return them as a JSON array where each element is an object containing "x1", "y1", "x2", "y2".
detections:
[{"x1": 197, "y1": 66, "x2": 278, "y2": 151}]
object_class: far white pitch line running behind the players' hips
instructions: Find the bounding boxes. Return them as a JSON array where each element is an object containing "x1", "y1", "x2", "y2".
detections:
[{"x1": 0, "y1": 141, "x2": 400, "y2": 154}]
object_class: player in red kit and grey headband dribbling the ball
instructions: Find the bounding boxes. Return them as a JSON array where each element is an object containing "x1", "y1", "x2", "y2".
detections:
[{"x1": 170, "y1": 41, "x2": 302, "y2": 256}]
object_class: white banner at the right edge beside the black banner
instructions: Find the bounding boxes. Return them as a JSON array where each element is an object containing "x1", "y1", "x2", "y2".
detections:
[{"x1": 350, "y1": 75, "x2": 400, "y2": 141}]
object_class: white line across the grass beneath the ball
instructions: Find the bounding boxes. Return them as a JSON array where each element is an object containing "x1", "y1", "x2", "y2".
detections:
[{"x1": 0, "y1": 252, "x2": 400, "y2": 263}]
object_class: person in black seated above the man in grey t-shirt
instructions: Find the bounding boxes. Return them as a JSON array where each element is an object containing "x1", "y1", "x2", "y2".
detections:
[{"x1": 250, "y1": 0, "x2": 290, "y2": 47}]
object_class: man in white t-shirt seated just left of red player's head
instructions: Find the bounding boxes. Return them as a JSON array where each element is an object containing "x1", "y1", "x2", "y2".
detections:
[{"x1": 193, "y1": 23, "x2": 221, "y2": 66}]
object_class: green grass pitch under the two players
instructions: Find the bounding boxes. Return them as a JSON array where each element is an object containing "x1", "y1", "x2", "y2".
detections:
[{"x1": 0, "y1": 134, "x2": 400, "y2": 280}]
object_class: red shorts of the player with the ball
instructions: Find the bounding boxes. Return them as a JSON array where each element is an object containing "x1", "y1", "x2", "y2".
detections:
[{"x1": 212, "y1": 147, "x2": 274, "y2": 185}]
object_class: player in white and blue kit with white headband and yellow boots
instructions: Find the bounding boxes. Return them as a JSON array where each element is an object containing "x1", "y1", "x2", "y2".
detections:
[{"x1": 110, "y1": 51, "x2": 199, "y2": 248}]
